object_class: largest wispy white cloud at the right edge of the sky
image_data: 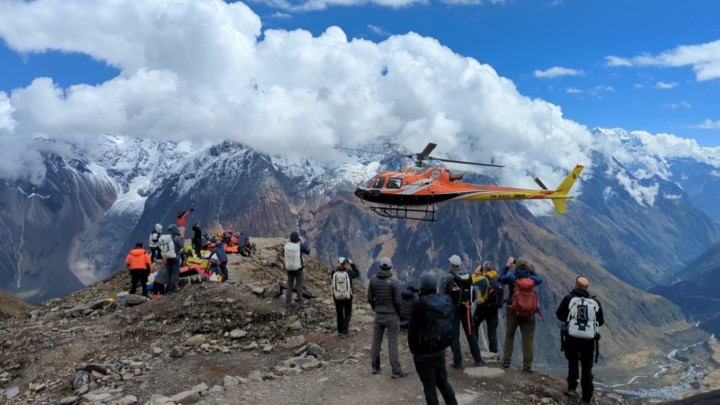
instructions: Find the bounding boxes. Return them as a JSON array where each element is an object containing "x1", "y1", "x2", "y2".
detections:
[{"x1": 605, "y1": 40, "x2": 720, "y2": 81}]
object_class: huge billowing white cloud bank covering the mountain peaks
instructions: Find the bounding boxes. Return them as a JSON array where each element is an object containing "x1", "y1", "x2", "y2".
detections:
[{"x1": 0, "y1": 0, "x2": 593, "y2": 187}]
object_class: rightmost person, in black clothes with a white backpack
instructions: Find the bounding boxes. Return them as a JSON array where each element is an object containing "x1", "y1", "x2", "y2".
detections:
[{"x1": 555, "y1": 276, "x2": 605, "y2": 403}]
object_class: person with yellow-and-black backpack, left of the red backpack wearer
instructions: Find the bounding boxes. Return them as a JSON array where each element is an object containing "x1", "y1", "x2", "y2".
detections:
[{"x1": 472, "y1": 261, "x2": 504, "y2": 354}]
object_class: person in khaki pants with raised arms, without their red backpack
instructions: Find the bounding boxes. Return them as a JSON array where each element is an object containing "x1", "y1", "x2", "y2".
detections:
[{"x1": 498, "y1": 256, "x2": 543, "y2": 373}]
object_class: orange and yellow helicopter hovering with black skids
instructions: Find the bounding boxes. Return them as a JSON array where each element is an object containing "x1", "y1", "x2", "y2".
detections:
[{"x1": 348, "y1": 143, "x2": 584, "y2": 221}]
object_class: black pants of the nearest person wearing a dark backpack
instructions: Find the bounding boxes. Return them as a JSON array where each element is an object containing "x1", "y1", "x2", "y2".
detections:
[{"x1": 413, "y1": 350, "x2": 457, "y2": 405}]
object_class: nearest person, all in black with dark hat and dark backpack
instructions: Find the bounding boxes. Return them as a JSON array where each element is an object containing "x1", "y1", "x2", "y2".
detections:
[{"x1": 408, "y1": 272, "x2": 458, "y2": 405}]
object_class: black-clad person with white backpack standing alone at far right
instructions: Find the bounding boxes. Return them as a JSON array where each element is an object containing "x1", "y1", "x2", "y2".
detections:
[{"x1": 555, "y1": 276, "x2": 605, "y2": 403}]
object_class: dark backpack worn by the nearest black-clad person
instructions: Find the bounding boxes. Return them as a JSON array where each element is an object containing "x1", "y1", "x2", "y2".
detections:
[{"x1": 417, "y1": 294, "x2": 457, "y2": 353}]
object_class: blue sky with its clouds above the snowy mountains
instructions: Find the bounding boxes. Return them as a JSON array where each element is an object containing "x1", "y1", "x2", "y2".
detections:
[{"x1": 0, "y1": 0, "x2": 720, "y2": 185}]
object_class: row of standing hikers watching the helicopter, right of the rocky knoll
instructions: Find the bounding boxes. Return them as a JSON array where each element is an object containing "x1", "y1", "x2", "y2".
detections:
[{"x1": 296, "y1": 246, "x2": 604, "y2": 404}]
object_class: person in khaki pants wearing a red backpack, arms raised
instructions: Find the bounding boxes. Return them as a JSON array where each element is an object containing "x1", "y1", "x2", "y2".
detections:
[{"x1": 498, "y1": 256, "x2": 543, "y2": 373}]
